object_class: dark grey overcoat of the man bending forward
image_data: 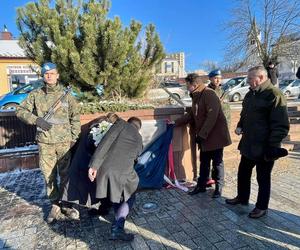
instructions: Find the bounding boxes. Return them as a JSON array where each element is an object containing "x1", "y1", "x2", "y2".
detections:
[{"x1": 89, "y1": 119, "x2": 143, "y2": 203}]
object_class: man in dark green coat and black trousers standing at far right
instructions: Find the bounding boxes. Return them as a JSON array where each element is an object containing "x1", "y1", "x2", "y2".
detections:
[{"x1": 226, "y1": 66, "x2": 289, "y2": 218}]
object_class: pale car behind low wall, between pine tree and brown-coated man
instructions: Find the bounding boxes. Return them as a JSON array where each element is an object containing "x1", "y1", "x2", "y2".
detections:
[{"x1": 146, "y1": 82, "x2": 188, "y2": 105}]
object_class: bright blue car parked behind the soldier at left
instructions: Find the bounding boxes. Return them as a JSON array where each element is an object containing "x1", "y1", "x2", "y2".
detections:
[{"x1": 0, "y1": 80, "x2": 44, "y2": 110}]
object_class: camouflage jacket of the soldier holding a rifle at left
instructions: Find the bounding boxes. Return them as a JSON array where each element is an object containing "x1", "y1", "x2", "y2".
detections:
[{"x1": 16, "y1": 85, "x2": 80, "y2": 144}]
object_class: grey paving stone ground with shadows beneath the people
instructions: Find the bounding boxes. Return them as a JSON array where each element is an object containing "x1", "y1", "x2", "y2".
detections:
[{"x1": 0, "y1": 155, "x2": 300, "y2": 250}]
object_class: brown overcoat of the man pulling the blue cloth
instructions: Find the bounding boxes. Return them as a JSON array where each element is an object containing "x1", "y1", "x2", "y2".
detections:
[{"x1": 175, "y1": 84, "x2": 231, "y2": 152}]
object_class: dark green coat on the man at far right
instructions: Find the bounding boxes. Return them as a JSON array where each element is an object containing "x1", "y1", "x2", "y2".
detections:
[{"x1": 237, "y1": 80, "x2": 289, "y2": 160}]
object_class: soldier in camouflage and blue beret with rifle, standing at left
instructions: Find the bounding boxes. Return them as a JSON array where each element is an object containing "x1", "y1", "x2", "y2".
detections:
[{"x1": 16, "y1": 63, "x2": 80, "y2": 223}]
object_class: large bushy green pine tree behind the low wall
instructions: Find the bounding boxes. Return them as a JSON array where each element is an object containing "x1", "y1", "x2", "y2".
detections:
[{"x1": 17, "y1": 0, "x2": 164, "y2": 97}]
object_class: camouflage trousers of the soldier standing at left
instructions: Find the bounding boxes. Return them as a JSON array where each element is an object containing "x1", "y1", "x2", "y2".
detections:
[{"x1": 39, "y1": 142, "x2": 71, "y2": 203}]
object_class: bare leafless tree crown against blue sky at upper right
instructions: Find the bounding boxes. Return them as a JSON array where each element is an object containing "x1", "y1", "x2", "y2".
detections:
[{"x1": 225, "y1": 0, "x2": 300, "y2": 66}]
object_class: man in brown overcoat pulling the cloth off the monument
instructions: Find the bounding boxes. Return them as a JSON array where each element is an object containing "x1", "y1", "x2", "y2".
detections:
[{"x1": 175, "y1": 73, "x2": 231, "y2": 198}]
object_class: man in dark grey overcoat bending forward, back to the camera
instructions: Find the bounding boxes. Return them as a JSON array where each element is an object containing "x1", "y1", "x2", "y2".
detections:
[{"x1": 89, "y1": 117, "x2": 143, "y2": 241}]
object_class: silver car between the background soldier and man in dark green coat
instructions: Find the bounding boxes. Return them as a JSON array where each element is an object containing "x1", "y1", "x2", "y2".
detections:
[{"x1": 222, "y1": 76, "x2": 250, "y2": 102}]
